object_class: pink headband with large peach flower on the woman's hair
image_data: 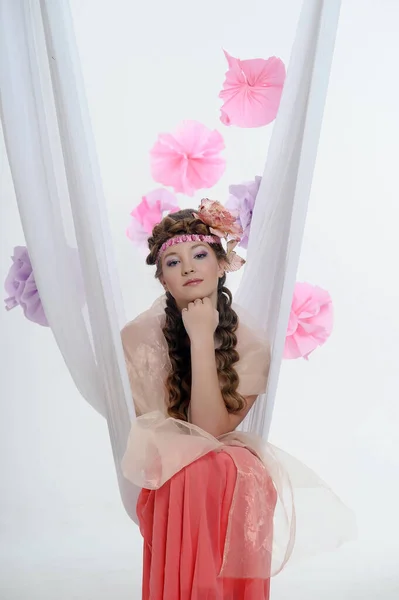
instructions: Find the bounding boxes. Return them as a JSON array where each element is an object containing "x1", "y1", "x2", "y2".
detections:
[{"x1": 157, "y1": 198, "x2": 245, "y2": 272}]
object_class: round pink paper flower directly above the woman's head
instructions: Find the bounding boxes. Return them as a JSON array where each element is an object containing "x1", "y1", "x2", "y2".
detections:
[{"x1": 150, "y1": 121, "x2": 226, "y2": 196}]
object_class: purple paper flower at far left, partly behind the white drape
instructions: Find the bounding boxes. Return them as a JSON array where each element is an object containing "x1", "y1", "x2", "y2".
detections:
[{"x1": 4, "y1": 246, "x2": 49, "y2": 327}]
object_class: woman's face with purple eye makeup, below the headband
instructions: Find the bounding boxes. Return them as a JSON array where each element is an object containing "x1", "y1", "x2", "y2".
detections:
[{"x1": 160, "y1": 242, "x2": 224, "y2": 309}]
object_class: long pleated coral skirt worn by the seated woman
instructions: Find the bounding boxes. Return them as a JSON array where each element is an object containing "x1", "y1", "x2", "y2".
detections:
[{"x1": 137, "y1": 447, "x2": 277, "y2": 600}]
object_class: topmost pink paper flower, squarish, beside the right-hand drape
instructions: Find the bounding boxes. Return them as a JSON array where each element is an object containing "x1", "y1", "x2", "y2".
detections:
[{"x1": 219, "y1": 51, "x2": 286, "y2": 127}]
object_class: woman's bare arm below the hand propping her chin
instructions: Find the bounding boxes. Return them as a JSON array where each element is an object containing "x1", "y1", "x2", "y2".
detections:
[{"x1": 190, "y1": 328, "x2": 257, "y2": 437}]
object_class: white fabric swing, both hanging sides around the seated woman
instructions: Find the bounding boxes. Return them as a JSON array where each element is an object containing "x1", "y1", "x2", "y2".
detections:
[{"x1": 0, "y1": 0, "x2": 340, "y2": 519}]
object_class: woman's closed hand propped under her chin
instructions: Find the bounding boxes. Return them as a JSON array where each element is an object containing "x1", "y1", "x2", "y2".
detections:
[{"x1": 182, "y1": 298, "x2": 219, "y2": 341}]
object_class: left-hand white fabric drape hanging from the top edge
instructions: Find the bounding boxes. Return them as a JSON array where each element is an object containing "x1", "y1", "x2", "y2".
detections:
[{"x1": 0, "y1": 0, "x2": 139, "y2": 519}]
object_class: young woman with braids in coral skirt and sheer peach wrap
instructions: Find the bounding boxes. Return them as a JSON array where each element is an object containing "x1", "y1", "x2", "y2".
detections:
[{"x1": 122, "y1": 203, "x2": 350, "y2": 600}]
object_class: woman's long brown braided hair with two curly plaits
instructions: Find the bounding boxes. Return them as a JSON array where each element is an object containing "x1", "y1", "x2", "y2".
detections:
[{"x1": 146, "y1": 209, "x2": 244, "y2": 421}]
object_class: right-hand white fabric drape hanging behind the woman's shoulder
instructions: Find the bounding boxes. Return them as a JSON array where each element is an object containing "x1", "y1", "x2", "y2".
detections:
[{"x1": 235, "y1": 0, "x2": 341, "y2": 439}]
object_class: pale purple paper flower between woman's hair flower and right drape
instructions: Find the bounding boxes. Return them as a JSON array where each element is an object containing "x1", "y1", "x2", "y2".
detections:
[{"x1": 226, "y1": 176, "x2": 262, "y2": 248}]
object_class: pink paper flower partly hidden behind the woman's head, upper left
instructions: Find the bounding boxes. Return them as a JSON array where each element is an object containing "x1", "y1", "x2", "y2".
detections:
[{"x1": 126, "y1": 188, "x2": 180, "y2": 246}]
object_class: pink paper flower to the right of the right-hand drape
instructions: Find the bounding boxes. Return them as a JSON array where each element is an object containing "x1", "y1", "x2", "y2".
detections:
[{"x1": 284, "y1": 283, "x2": 333, "y2": 360}]
